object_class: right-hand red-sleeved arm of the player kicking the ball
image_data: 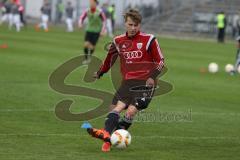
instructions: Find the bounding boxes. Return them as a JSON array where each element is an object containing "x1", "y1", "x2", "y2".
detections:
[{"x1": 149, "y1": 38, "x2": 164, "y2": 79}]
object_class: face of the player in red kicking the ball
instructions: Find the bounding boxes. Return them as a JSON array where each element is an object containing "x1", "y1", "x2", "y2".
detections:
[{"x1": 125, "y1": 17, "x2": 140, "y2": 37}]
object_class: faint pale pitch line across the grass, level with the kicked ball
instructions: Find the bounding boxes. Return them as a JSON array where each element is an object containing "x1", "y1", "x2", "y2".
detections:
[{"x1": 0, "y1": 133, "x2": 240, "y2": 140}]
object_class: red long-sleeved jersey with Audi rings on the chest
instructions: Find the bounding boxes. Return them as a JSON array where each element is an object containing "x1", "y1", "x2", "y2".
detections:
[{"x1": 99, "y1": 32, "x2": 164, "y2": 80}]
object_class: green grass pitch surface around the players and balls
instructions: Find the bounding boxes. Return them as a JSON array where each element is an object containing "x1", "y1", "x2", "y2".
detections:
[{"x1": 0, "y1": 26, "x2": 240, "y2": 160}]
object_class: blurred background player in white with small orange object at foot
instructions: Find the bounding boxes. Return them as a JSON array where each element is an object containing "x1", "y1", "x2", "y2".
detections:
[{"x1": 36, "y1": 0, "x2": 51, "y2": 32}]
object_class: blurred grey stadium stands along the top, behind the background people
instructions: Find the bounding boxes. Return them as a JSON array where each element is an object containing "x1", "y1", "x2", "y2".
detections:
[{"x1": 2, "y1": 0, "x2": 240, "y2": 34}]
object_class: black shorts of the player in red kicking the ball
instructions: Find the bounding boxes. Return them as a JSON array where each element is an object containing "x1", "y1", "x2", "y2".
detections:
[{"x1": 112, "y1": 80, "x2": 155, "y2": 110}]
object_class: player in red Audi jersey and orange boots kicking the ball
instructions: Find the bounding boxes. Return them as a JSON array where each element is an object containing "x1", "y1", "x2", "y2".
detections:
[{"x1": 87, "y1": 9, "x2": 164, "y2": 152}]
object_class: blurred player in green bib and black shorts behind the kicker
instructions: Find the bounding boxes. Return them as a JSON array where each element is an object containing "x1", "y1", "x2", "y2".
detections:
[{"x1": 79, "y1": 0, "x2": 106, "y2": 64}]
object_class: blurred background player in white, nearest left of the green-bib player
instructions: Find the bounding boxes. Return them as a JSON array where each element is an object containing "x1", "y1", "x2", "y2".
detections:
[{"x1": 65, "y1": 2, "x2": 74, "y2": 32}]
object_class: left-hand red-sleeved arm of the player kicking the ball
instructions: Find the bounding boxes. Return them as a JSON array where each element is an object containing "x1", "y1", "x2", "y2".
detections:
[{"x1": 94, "y1": 43, "x2": 118, "y2": 79}]
